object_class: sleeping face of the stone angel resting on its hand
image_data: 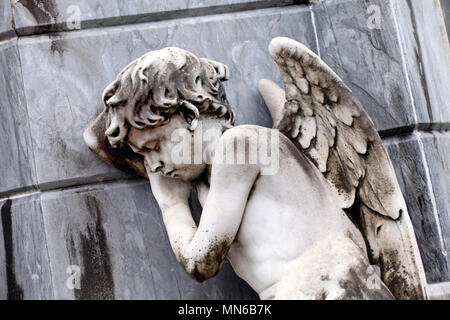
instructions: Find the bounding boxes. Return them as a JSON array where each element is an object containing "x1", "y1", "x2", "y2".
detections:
[{"x1": 127, "y1": 115, "x2": 206, "y2": 180}]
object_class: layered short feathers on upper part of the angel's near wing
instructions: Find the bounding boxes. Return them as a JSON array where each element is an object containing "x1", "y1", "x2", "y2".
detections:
[{"x1": 269, "y1": 38, "x2": 406, "y2": 219}]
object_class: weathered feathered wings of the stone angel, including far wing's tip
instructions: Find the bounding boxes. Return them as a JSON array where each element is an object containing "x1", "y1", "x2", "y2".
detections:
[{"x1": 259, "y1": 38, "x2": 426, "y2": 299}]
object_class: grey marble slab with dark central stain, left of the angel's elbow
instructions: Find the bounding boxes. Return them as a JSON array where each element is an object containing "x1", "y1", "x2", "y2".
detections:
[{"x1": 42, "y1": 180, "x2": 257, "y2": 299}]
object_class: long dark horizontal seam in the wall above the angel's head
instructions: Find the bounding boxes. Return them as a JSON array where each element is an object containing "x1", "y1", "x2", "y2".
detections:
[{"x1": 8, "y1": 0, "x2": 309, "y2": 37}]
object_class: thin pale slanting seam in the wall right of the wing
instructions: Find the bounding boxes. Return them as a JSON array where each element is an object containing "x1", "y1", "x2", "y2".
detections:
[{"x1": 389, "y1": 0, "x2": 447, "y2": 256}]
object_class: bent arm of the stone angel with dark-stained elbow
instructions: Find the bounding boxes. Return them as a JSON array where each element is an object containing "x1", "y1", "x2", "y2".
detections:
[{"x1": 149, "y1": 131, "x2": 259, "y2": 282}]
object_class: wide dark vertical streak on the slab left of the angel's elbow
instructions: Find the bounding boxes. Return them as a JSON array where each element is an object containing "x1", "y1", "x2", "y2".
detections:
[{"x1": 66, "y1": 195, "x2": 114, "y2": 300}]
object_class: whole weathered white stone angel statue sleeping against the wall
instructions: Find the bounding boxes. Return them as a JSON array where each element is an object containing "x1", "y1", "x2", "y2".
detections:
[{"x1": 84, "y1": 38, "x2": 427, "y2": 299}]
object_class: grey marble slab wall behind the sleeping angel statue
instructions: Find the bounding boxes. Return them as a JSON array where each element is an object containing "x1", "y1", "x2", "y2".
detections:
[{"x1": 0, "y1": 0, "x2": 450, "y2": 299}]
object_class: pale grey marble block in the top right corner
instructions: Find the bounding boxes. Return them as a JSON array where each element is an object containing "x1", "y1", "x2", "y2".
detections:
[{"x1": 392, "y1": 0, "x2": 450, "y2": 129}]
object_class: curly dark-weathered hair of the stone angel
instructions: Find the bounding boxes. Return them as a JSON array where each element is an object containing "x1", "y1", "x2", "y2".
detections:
[{"x1": 103, "y1": 47, "x2": 234, "y2": 147}]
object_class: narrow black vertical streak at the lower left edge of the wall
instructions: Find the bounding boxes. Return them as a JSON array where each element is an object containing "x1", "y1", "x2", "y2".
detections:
[{"x1": 2, "y1": 199, "x2": 23, "y2": 300}]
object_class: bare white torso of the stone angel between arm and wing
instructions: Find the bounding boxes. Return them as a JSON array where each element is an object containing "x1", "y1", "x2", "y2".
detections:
[{"x1": 228, "y1": 134, "x2": 367, "y2": 298}]
